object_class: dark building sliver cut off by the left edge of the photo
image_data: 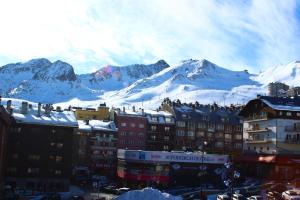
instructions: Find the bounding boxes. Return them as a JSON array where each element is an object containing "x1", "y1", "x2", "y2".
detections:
[{"x1": 0, "y1": 104, "x2": 11, "y2": 199}]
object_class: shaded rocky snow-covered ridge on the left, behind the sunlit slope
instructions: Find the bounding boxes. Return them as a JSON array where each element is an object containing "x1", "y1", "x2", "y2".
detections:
[{"x1": 0, "y1": 58, "x2": 169, "y2": 102}]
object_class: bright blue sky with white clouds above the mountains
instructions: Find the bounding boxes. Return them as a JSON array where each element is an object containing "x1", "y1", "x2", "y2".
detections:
[{"x1": 0, "y1": 0, "x2": 300, "y2": 73}]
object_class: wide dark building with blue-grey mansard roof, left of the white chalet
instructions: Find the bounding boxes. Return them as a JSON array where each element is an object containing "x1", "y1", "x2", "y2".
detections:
[{"x1": 162, "y1": 100, "x2": 243, "y2": 154}]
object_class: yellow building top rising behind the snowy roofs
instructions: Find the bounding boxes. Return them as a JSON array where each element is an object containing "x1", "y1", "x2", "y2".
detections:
[{"x1": 73, "y1": 103, "x2": 109, "y2": 120}]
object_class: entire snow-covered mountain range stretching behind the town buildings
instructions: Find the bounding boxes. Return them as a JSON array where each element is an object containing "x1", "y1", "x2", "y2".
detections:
[{"x1": 0, "y1": 58, "x2": 300, "y2": 108}]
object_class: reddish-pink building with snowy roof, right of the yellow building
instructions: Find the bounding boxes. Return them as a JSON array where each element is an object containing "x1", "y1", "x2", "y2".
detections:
[{"x1": 114, "y1": 106, "x2": 147, "y2": 150}]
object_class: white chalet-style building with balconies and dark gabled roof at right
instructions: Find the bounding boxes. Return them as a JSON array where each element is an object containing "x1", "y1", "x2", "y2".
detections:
[{"x1": 240, "y1": 96, "x2": 300, "y2": 179}]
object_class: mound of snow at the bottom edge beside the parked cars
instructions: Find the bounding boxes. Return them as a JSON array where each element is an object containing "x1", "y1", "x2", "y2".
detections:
[{"x1": 116, "y1": 188, "x2": 182, "y2": 200}]
